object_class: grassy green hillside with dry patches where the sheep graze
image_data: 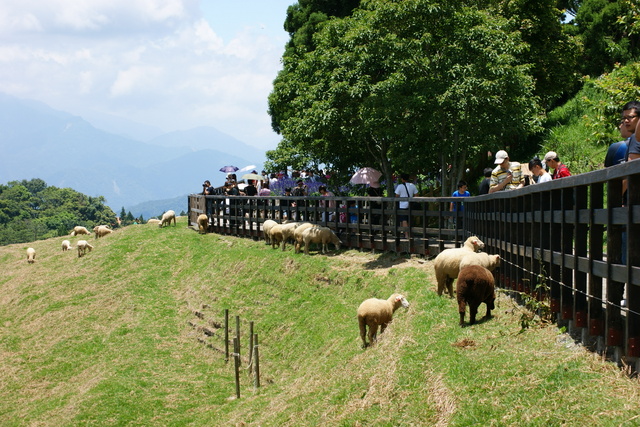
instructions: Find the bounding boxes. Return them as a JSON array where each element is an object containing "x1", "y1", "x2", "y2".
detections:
[{"x1": 0, "y1": 219, "x2": 640, "y2": 426}]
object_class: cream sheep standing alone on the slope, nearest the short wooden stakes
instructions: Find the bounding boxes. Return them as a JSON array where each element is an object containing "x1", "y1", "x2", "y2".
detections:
[{"x1": 358, "y1": 294, "x2": 409, "y2": 348}]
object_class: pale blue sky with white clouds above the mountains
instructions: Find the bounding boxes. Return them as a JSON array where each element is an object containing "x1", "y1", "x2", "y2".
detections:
[{"x1": 0, "y1": 0, "x2": 296, "y2": 149}]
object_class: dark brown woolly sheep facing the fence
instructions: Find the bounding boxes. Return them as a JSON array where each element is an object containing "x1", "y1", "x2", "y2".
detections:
[{"x1": 456, "y1": 265, "x2": 496, "y2": 326}]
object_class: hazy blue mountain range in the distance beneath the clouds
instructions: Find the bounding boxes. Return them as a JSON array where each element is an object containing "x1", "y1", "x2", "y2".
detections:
[{"x1": 0, "y1": 94, "x2": 265, "y2": 218}]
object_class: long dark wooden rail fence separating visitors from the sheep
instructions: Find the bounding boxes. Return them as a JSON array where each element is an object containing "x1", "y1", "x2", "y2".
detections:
[{"x1": 189, "y1": 161, "x2": 640, "y2": 361}]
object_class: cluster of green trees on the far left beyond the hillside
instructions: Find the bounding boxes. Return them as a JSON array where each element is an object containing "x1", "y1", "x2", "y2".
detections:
[{"x1": 0, "y1": 178, "x2": 117, "y2": 245}]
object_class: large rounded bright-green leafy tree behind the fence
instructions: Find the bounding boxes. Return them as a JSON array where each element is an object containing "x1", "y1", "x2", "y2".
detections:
[{"x1": 268, "y1": 0, "x2": 539, "y2": 194}]
